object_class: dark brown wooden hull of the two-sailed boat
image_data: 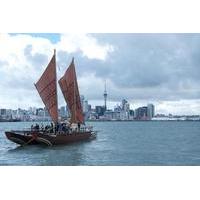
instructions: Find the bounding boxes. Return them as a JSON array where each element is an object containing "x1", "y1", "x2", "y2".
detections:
[{"x1": 5, "y1": 131, "x2": 96, "y2": 146}]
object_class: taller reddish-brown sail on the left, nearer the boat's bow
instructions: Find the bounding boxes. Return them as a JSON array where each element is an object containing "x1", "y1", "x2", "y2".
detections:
[{"x1": 35, "y1": 53, "x2": 58, "y2": 123}]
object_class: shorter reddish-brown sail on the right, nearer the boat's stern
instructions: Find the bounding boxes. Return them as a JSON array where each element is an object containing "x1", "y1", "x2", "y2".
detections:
[{"x1": 59, "y1": 58, "x2": 84, "y2": 123}]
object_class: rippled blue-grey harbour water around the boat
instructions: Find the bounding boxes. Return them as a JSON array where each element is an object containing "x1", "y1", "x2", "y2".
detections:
[{"x1": 0, "y1": 121, "x2": 200, "y2": 166}]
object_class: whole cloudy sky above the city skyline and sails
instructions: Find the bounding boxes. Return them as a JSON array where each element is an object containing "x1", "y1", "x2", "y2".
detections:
[{"x1": 0, "y1": 34, "x2": 200, "y2": 114}]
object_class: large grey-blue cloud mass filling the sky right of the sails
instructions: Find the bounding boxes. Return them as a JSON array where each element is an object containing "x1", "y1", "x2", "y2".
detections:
[{"x1": 81, "y1": 34, "x2": 200, "y2": 100}]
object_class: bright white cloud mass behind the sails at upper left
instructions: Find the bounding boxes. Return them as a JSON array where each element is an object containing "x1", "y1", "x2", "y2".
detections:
[{"x1": 0, "y1": 34, "x2": 112, "y2": 108}]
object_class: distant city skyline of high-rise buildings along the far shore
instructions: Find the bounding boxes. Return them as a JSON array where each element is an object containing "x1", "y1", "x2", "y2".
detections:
[{"x1": 0, "y1": 99, "x2": 200, "y2": 122}]
